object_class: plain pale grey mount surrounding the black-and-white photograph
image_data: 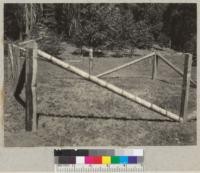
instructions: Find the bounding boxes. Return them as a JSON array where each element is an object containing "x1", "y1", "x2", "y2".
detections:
[{"x1": 0, "y1": 0, "x2": 200, "y2": 172}]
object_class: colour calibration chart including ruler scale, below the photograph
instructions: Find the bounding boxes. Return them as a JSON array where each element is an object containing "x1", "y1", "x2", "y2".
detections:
[{"x1": 54, "y1": 149, "x2": 144, "y2": 173}]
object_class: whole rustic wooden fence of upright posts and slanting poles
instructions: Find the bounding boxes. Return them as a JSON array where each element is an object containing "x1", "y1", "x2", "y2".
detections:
[{"x1": 8, "y1": 40, "x2": 196, "y2": 131}]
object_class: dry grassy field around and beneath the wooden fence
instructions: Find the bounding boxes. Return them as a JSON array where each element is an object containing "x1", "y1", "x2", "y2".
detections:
[{"x1": 4, "y1": 43, "x2": 196, "y2": 147}]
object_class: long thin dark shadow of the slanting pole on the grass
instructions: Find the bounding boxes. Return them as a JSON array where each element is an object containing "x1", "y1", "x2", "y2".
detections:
[{"x1": 37, "y1": 113, "x2": 176, "y2": 122}]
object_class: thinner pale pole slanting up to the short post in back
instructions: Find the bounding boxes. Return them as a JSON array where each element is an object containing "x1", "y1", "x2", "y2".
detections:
[{"x1": 97, "y1": 52, "x2": 155, "y2": 77}]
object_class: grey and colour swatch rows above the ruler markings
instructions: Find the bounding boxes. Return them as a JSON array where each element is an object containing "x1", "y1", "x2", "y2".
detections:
[{"x1": 54, "y1": 149, "x2": 143, "y2": 165}]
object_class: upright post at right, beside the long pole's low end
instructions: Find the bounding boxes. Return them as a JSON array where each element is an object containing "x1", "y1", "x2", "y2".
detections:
[{"x1": 180, "y1": 53, "x2": 192, "y2": 121}]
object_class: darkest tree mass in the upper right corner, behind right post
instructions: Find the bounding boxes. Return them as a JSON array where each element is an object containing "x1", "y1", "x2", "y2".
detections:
[{"x1": 163, "y1": 4, "x2": 197, "y2": 54}]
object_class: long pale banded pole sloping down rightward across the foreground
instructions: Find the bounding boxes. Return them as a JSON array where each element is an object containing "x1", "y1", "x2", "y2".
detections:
[{"x1": 38, "y1": 50, "x2": 182, "y2": 121}]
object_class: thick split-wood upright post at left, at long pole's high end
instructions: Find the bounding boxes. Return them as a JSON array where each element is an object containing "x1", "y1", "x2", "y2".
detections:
[{"x1": 25, "y1": 42, "x2": 37, "y2": 131}]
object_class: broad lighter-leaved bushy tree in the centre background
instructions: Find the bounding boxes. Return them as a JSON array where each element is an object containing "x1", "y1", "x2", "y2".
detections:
[{"x1": 70, "y1": 4, "x2": 154, "y2": 48}]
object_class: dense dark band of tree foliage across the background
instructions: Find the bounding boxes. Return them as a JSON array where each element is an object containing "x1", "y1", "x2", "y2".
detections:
[{"x1": 4, "y1": 3, "x2": 197, "y2": 54}]
